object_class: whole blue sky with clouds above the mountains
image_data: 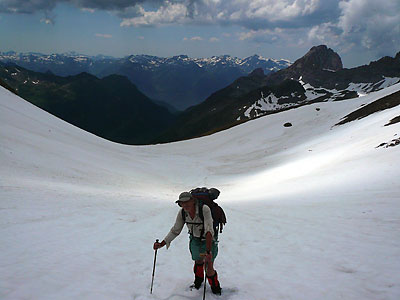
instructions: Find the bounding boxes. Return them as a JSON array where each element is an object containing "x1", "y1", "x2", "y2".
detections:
[{"x1": 0, "y1": 0, "x2": 400, "y2": 67}]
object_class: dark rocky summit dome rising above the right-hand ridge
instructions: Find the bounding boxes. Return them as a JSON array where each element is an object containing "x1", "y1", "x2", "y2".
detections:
[{"x1": 290, "y1": 45, "x2": 343, "y2": 71}]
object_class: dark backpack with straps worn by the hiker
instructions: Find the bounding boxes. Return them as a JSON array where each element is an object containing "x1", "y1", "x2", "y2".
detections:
[{"x1": 182, "y1": 187, "x2": 226, "y2": 237}]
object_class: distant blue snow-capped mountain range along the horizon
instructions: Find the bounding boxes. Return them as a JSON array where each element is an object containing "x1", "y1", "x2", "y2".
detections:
[{"x1": 0, "y1": 52, "x2": 291, "y2": 110}]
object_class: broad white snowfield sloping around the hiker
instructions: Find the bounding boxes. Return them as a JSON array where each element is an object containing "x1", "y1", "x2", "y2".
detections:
[{"x1": 0, "y1": 84, "x2": 400, "y2": 300}]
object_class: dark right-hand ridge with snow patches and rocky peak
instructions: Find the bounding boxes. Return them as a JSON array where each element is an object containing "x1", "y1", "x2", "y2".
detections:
[{"x1": 158, "y1": 45, "x2": 400, "y2": 142}]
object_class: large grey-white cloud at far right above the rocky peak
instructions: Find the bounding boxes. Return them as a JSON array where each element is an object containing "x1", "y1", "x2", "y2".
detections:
[{"x1": 308, "y1": 0, "x2": 400, "y2": 57}]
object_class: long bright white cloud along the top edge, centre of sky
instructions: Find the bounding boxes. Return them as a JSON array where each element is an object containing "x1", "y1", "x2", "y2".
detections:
[{"x1": 114, "y1": 0, "x2": 338, "y2": 29}]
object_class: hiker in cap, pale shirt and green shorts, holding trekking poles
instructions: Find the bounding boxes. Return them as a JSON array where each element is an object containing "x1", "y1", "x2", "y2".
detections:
[{"x1": 153, "y1": 192, "x2": 221, "y2": 295}]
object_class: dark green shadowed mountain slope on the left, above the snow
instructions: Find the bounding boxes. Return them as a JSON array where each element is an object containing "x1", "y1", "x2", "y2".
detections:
[{"x1": 0, "y1": 62, "x2": 175, "y2": 144}]
